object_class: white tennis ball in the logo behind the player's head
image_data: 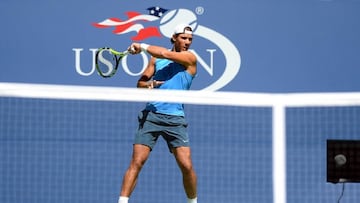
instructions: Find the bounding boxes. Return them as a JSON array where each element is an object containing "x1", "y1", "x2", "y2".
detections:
[{"x1": 159, "y1": 9, "x2": 197, "y2": 38}]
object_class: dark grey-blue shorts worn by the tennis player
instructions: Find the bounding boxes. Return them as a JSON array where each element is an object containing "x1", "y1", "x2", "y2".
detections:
[{"x1": 134, "y1": 110, "x2": 190, "y2": 152}]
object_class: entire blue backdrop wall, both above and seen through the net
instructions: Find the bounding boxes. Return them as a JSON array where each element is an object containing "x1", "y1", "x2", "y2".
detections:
[{"x1": 0, "y1": 0, "x2": 360, "y2": 203}]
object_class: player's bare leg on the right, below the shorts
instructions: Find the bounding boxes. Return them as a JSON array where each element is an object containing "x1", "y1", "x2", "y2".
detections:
[{"x1": 173, "y1": 147, "x2": 197, "y2": 202}]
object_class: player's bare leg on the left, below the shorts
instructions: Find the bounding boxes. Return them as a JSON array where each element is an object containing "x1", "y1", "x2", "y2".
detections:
[{"x1": 119, "y1": 144, "x2": 150, "y2": 202}]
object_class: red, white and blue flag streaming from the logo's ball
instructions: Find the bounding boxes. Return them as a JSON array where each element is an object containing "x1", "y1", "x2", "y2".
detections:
[{"x1": 92, "y1": 7, "x2": 168, "y2": 41}]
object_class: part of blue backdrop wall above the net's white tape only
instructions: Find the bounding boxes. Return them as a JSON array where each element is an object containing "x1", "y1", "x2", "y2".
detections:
[{"x1": 0, "y1": 0, "x2": 360, "y2": 92}]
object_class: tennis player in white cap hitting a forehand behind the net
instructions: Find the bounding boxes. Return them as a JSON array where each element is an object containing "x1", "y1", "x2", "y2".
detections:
[{"x1": 119, "y1": 24, "x2": 197, "y2": 203}]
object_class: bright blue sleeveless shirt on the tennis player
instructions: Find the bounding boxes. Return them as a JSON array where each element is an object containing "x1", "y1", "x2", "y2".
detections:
[{"x1": 145, "y1": 59, "x2": 194, "y2": 116}]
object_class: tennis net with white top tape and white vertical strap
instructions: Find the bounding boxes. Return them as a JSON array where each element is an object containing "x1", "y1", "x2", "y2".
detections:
[{"x1": 0, "y1": 83, "x2": 360, "y2": 203}]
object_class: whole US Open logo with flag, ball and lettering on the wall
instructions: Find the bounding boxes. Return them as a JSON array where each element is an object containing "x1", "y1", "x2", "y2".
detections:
[{"x1": 73, "y1": 7, "x2": 241, "y2": 91}]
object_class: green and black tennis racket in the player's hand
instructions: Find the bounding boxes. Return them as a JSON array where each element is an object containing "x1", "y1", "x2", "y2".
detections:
[{"x1": 95, "y1": 47, "x2": 129, "y2": 78}]
